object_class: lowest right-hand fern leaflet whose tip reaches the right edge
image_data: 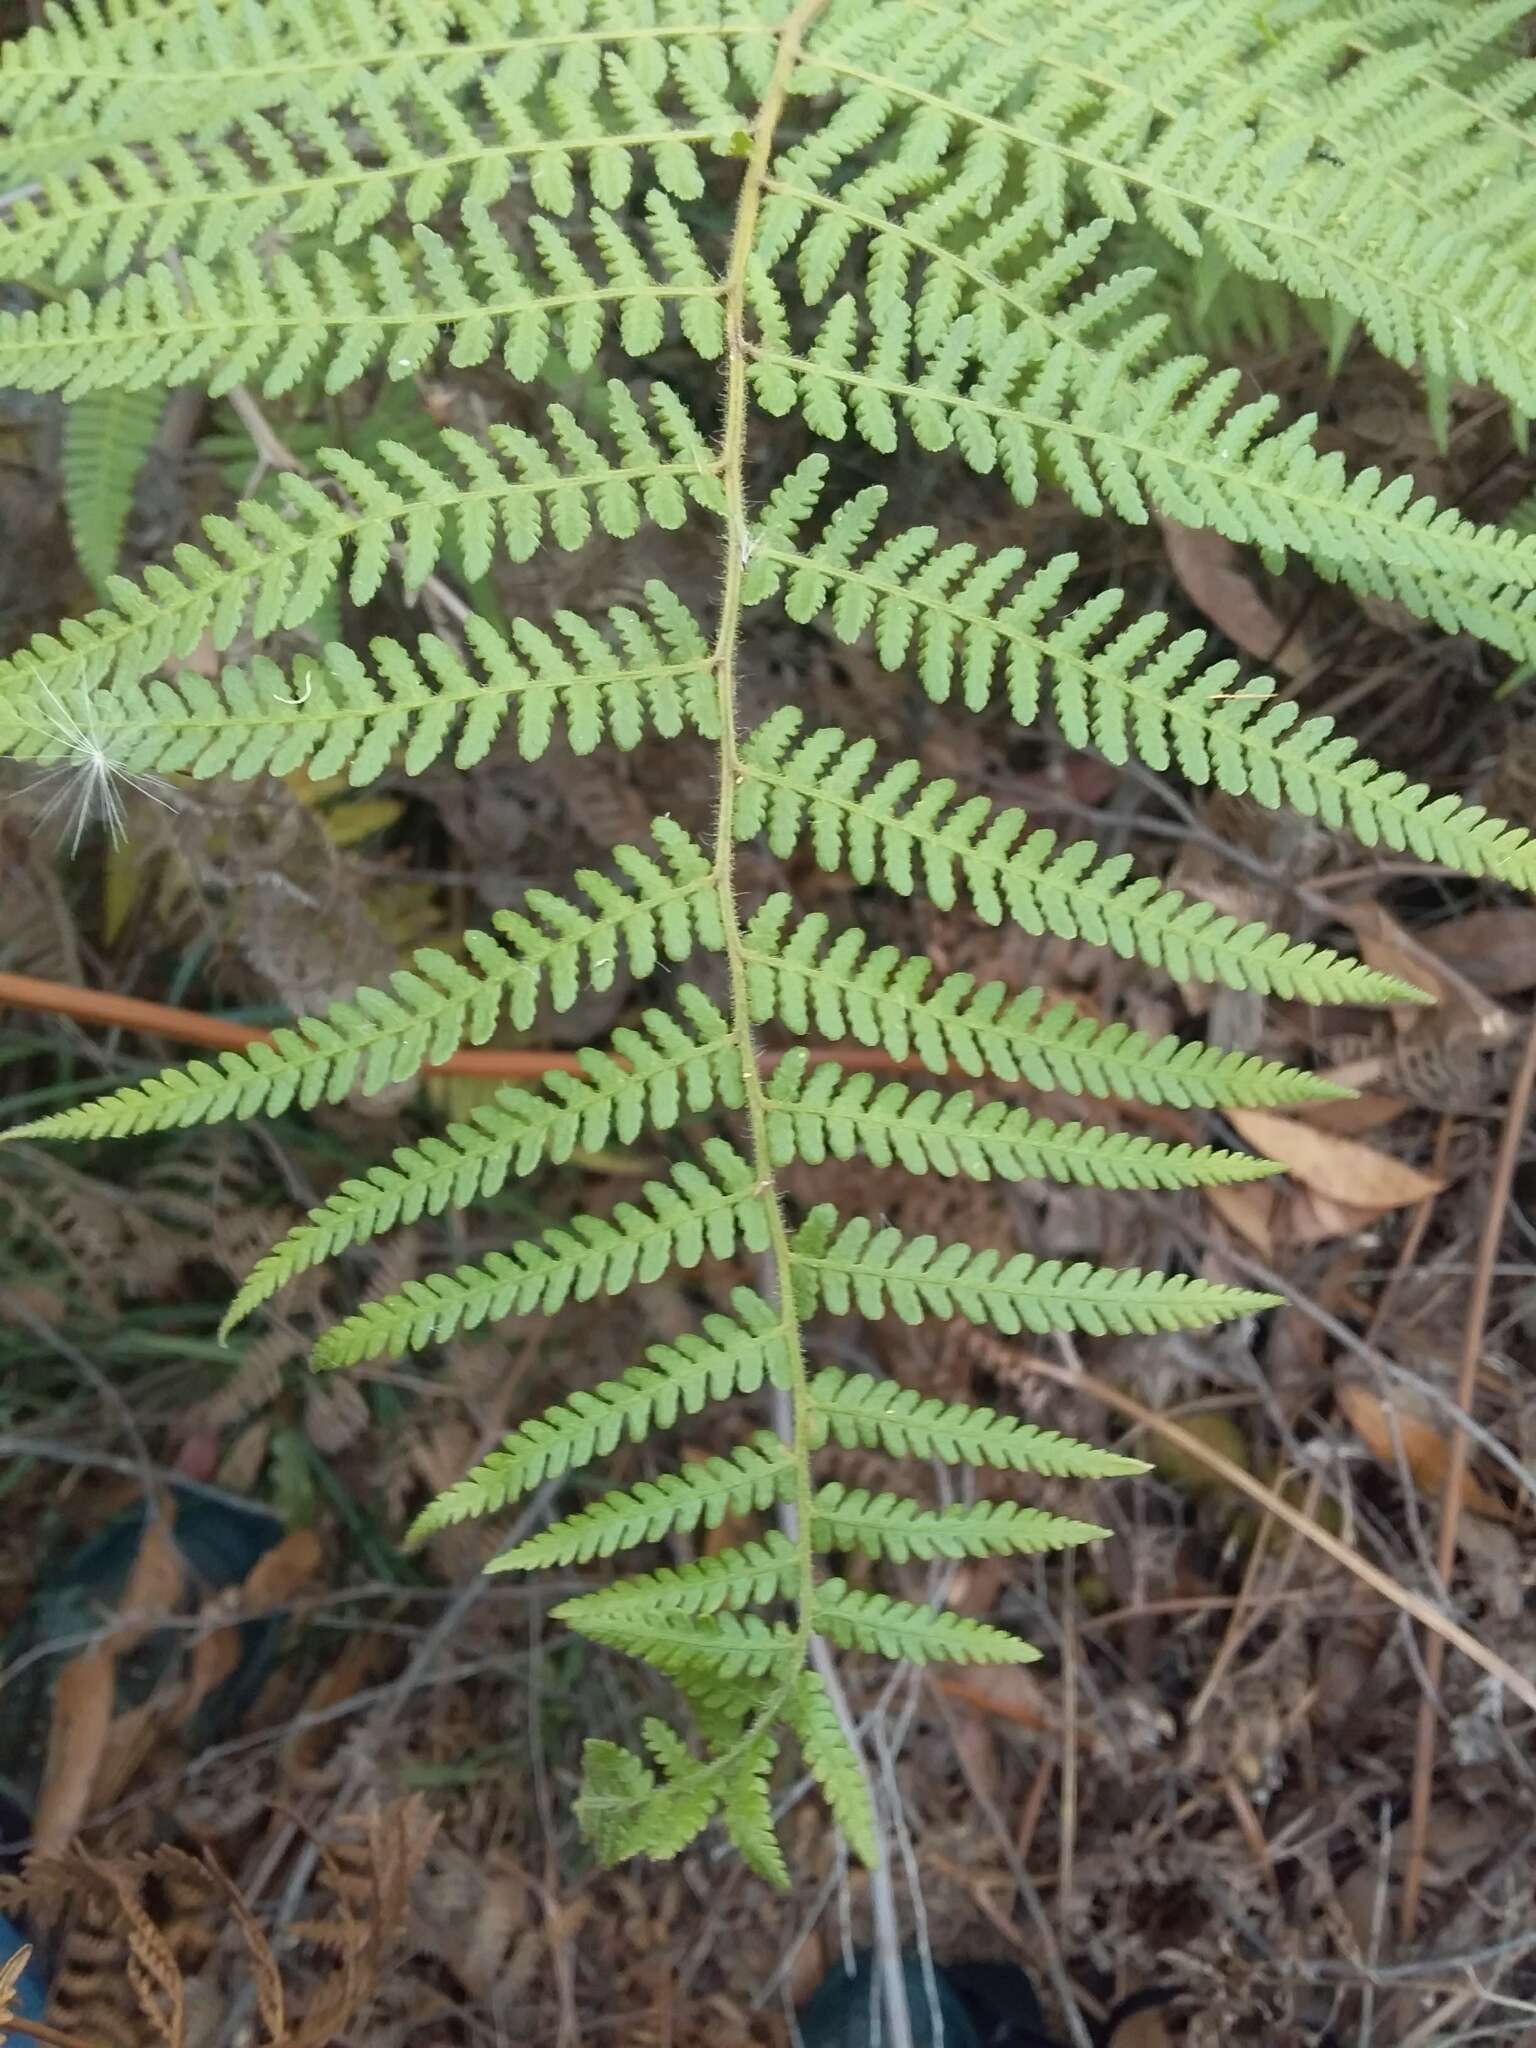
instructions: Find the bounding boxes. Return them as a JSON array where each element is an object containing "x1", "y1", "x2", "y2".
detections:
[{"x1": 752, "y1": 475, "x2": 1536, "y2": 889}]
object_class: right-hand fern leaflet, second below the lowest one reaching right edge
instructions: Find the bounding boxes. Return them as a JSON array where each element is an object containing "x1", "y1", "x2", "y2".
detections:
[{"x1": 743, "y1": 895, "x2": 1339, "y2": 1110}]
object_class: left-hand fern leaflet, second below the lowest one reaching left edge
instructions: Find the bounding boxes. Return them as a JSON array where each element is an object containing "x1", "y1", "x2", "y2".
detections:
[{"x1": 313, "y1": 1139, "x2": 768, "y2": 1370}]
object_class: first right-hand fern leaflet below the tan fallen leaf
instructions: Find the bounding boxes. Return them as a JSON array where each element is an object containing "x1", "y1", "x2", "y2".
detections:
[{"x1": 791, "y1": 1202, "x2": 1278, "y2": 1337}]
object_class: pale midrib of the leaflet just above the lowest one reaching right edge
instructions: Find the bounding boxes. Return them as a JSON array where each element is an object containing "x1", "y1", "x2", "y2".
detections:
[{"x1": 748, "y1": 342, "x2": 1536, "y2": 602}]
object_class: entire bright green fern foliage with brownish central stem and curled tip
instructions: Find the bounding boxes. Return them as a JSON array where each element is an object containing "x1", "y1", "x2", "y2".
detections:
[{"x1": 0, "y1": 0, "x2": 1536, "y2": 1878}]
